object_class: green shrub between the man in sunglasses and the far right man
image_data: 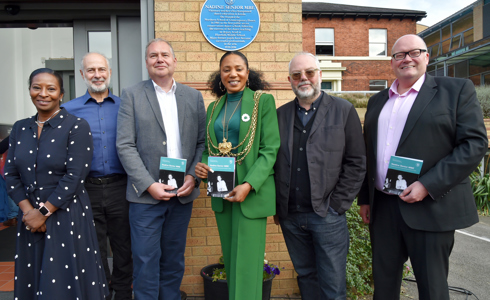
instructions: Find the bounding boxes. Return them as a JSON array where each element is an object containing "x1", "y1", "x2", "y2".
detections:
[{"x1": 346, "y1": 200, "x2": 373, "y2": 299}]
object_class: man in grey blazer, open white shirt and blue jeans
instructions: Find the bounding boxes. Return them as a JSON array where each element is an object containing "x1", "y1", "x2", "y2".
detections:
[{"x1": 116, "y1": 39, "x2": 206, "y2": 300}]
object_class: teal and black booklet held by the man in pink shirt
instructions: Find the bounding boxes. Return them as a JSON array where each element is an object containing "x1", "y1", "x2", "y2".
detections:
[{"x1": 383, "y1": 156, "x2": 424, "y2": 195}]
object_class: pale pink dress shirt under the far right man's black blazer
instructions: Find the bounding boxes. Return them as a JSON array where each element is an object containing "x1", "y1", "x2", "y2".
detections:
[{"x1": 376, "y1": 74, "x2": 425, "y2": 191}]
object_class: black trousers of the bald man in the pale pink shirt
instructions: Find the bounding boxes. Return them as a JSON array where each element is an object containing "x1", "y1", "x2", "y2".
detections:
[{"x1": 370, "y1": 191, "x2": 454, "y2": 300}]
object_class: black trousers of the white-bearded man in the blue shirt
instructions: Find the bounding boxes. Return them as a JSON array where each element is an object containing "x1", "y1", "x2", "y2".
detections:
[{"x1": 85, "y1": 176, "x2": 133, "y2": 300}]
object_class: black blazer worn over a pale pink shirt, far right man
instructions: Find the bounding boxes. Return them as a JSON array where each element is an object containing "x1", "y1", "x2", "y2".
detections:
[{"x1": 358, "y1": 75, "x2": 488, "y2": 231}]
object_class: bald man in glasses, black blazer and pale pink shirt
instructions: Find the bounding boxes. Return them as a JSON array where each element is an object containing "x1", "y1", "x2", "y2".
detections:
[{"x1": 358, "y1": 35, "x2": 488, "y2": 300}]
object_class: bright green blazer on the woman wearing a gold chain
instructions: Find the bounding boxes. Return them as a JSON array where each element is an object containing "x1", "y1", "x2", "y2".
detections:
[{"x1": 202, "y1": 88, "x2": 280, "y2": 219}]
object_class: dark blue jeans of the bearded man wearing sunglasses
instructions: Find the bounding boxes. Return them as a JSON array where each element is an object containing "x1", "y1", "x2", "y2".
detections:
[{"x1": 279, "y1": 211, "x2": 349, "y2": 300}]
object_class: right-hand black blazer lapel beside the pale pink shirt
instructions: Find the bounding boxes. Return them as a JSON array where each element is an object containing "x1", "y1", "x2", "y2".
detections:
[{"x1": 398, "y1": 74, "x2": 437, "y2": 149}]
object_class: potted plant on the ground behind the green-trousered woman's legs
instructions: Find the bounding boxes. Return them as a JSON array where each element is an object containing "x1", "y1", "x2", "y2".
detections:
[{"x1": 201, "y1": 256, "x2": 281, "y2": 300}]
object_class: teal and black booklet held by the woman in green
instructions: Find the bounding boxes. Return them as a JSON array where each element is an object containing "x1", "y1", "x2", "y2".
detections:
[{"x1": 207, "y1": 156, "x2": 235, "y2": 198}]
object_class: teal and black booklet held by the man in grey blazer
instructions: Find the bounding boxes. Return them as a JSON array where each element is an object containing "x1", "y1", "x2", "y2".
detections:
[{"x1": 158, "y1": 156, "x2": 187, "y2": 194}]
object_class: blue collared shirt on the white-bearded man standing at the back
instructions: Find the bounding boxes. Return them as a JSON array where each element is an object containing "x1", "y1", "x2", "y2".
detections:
[{"x1": 62, "y1": 90, "x2": 126, "y2": 177}]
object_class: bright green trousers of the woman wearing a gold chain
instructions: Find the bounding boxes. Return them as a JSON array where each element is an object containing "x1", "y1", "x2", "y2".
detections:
[{"x1": 215, "y1": 200, "x2": 267, "y2": 300}]
